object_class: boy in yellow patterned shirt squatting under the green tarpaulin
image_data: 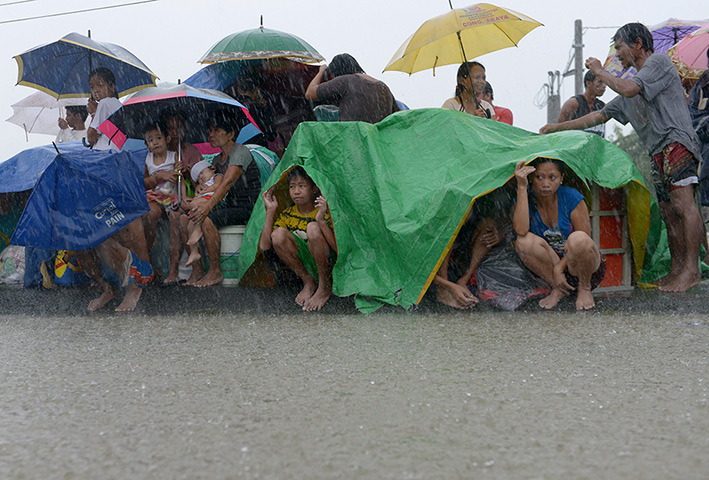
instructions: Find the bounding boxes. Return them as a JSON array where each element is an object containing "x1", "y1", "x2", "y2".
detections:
[{"x1": 259, "y1": 167, "x2": 337, "y2": 311}]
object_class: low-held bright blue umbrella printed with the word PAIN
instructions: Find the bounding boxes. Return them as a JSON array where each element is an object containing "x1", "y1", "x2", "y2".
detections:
[{"x1": 11, "y1": 148, "x2": 148, "y2": 250}]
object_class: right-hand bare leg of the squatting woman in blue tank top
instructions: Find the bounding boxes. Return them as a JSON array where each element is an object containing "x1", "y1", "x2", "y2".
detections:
[{"x1": 565, "y1": 231, "x2": 601, "y2": 310}]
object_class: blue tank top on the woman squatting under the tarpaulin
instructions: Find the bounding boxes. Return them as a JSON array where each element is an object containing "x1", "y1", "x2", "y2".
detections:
[{"x1": 529, "y1": 185, "x2": 583, "y2": 257}]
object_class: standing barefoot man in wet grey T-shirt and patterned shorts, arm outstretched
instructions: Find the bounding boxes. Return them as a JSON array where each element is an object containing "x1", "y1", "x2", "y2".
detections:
[{"x1": 539, "y1": 23, "x2": 706, "y2": 292}]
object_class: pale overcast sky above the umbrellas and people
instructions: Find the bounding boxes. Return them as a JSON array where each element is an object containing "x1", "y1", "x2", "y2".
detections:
[{"x1": 0, "y1": 0, "x2": 709, "y2": 161}]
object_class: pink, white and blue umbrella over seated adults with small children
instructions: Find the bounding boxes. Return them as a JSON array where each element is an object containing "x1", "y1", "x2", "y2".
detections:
[{"x1": 99, "y1": 84, "x2": 260, "y2": 147}]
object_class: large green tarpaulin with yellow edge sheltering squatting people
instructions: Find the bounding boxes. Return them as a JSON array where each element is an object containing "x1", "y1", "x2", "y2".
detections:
[{"x1": 239, "y1": 109, "x2": 666, "y2": 312}]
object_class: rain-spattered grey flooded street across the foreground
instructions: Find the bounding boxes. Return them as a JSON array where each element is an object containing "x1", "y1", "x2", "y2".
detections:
[{"x1": 0, "y1": 313, "x2": 709, "y2": 479}]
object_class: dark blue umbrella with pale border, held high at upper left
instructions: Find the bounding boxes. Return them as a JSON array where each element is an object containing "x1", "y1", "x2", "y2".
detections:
[{"x1": 14, "y1": 33, "x2": 158, "y2": 98}]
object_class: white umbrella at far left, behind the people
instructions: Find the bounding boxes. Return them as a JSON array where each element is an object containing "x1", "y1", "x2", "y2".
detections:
[{"x1": 7, "y1": 92, "x2": 86, "y2": 135}]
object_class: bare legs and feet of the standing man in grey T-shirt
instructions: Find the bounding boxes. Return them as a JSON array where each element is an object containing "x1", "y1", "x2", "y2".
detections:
[{"x1": 660, "y1": 185, "x2": 704, "y2": 292}]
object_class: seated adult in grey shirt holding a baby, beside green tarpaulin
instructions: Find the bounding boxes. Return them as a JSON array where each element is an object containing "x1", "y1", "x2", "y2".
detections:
[{"x1": 182, "y1": 109, "x2": 261, "y2": 287}]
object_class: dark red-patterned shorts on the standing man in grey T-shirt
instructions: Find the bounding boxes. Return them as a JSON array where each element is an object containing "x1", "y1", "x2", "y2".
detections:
[{"x1": 651, "y1": 142, "x2": 699, "y2": 202}]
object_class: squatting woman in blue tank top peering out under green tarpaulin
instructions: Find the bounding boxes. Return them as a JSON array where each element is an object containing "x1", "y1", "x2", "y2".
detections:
[{"x1": 513, "y1": 157, "x2": 605, "y2": 310}]
